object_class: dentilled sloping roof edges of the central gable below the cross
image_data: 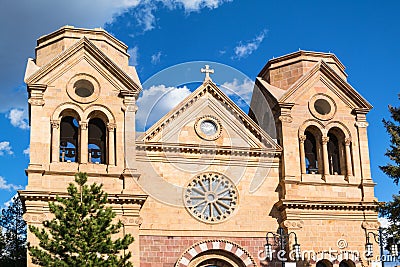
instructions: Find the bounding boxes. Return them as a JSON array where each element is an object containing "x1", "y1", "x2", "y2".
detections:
[{"x1": 141, "y1": 80, "x2": 282, "y2": 151}]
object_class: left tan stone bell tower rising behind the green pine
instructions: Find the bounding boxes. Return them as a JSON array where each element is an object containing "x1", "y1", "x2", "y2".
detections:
[{"x1": 20, "y1": 26, "x2": 146, "y2": 264}]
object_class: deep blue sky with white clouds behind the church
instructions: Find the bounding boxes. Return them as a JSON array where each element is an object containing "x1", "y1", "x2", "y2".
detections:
[{"x1": 0, "y1": 0, "x2": 400, "y2": 211}]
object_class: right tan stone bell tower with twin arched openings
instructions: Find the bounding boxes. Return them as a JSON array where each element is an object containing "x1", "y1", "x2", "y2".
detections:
[{"x1": 250, "y1": 51, "x2": 379, "y2": 266}]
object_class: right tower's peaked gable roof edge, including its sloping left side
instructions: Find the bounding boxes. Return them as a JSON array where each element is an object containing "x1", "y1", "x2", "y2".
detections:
[{"x1": 257, "y1": 60, "x2": 372, "y2": 110}]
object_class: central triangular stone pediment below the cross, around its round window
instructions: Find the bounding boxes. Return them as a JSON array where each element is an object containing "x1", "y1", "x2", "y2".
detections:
[{"x1": 140, "y1": 81, "x2": 281, "y2": 153}]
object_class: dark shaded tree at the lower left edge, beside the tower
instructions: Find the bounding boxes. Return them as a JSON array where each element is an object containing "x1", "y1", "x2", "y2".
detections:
[{"x1": 0, "y1": 197, "x2": 27, "y2": 266}]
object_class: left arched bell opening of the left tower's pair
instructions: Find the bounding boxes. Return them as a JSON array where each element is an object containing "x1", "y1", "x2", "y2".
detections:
[{"x1": 60, "y1": 116, "x2": 79, "y2": 162}]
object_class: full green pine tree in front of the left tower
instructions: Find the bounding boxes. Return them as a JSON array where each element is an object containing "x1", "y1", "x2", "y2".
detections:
[{"x1": 29, "y1": 173, "x2": 133, "y2": 267}]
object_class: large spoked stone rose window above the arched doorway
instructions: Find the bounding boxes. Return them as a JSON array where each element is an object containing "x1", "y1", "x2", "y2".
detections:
[{"x1": 184, "y1": 172, "x2": 238, "y2": 223}]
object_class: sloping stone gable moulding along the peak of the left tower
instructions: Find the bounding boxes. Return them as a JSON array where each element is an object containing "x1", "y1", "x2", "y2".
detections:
[{"x1": 25, "y1": 36, "x2": 141, "y2": 96}]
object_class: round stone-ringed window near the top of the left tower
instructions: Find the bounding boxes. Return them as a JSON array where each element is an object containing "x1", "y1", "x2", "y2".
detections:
[{"x1": 67, "y1": 73, "x2": 100, "y2": 103}]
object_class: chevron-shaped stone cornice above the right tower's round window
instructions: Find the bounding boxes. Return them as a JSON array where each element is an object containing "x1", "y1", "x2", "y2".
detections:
[{"x1": 277, "y1": 60, "x2": 372, "y2": 110}]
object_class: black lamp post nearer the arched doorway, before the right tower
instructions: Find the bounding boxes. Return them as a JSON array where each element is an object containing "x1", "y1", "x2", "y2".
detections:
[{"x1": 264, "y1": 227, "x2": 301, "y2": 267}]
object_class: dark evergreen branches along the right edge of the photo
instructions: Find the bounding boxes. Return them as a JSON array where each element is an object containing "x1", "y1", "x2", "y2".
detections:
[{"x1": 380, "y1": 102, "x2": 400, "y2": 243}]
